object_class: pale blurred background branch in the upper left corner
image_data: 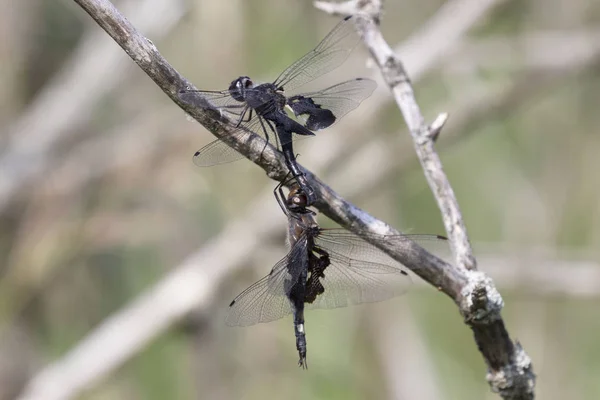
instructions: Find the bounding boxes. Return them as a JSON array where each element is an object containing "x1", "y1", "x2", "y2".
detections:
[{"x1": 0, "y1": 0, "x2": 185, "y2": 208}]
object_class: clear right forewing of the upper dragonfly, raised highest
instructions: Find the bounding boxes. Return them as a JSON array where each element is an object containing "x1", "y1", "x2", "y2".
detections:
[{"x1": 273, "y1": 17, "x2": 359, "y2": 91}]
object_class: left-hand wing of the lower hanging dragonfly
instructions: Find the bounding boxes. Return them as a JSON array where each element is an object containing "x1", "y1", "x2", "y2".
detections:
[{"x1": 225, "y1": 240, "x2": 306, "y2": 326}]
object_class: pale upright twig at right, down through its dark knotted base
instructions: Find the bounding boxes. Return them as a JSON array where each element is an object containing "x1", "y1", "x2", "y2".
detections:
[{"x1": 314, "y1": 0, "x2": 535, "y2": 399}]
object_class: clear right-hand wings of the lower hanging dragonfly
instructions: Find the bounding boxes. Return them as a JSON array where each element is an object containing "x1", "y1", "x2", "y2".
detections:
[{"x1": 306, "y1": 229, "x2": 445, "y2": 309}]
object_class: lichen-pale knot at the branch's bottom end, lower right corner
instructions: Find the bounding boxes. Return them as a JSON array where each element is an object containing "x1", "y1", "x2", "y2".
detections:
[{"x1": 486, "y1": 342, "x2": 535, "y2": 399}]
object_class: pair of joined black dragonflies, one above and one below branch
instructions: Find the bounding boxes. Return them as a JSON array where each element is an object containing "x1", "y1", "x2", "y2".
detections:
[{"x1": 180, "y1": 17, "x2": 445, "y2": 368}]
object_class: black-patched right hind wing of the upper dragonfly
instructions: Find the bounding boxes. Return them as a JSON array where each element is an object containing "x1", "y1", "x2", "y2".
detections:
[{"x1": 287, "y1": 78, "x2": 377, "y2": 130}]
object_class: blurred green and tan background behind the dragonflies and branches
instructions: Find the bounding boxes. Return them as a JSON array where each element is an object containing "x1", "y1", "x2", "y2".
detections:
[{"x1": 0, "y1": 0, "x2": 600, "y2": 400}]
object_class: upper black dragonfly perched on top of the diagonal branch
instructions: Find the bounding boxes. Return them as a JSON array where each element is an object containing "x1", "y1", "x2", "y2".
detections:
[{"x1": 179, "y1": 16, "x2": 377, "y2": 205}]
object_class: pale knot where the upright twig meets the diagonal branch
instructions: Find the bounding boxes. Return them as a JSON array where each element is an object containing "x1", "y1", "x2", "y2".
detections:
[{"x1": 460, "y1": 271, "x2": 504, "y2": 325}]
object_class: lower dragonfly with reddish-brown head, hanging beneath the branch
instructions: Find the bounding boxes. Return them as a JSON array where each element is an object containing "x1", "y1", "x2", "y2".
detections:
[{"x1": 226, "y1": 183, "x2": 447, "y2": 369}]
